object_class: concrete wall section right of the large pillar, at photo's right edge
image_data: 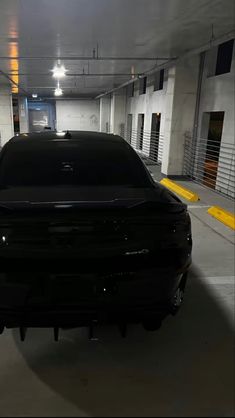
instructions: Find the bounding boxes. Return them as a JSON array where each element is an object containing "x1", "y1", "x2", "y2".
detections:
[{"x1": 198, "y1": 44, "x2": 235, "y2": 196}]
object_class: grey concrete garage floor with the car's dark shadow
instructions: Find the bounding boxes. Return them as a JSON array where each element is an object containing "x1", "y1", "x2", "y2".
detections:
[{"x1": 0, "y1": 172, "x2": 235, "y2": 417}]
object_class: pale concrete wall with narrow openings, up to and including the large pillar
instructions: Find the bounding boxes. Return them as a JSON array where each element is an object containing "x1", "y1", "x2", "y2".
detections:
[{"x1": 126, "y1": 60, "x2": 199, "y2": 175}]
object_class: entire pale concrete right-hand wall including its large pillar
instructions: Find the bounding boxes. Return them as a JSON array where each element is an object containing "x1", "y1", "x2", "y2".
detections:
[{"x1": 126, "y1": 43, "x2": 235, "y2": 189}]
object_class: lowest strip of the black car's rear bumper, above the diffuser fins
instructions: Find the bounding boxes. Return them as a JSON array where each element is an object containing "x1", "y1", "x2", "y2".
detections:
[{"x1": 0, "y1": 301, "x2": 176, "y2": 328}]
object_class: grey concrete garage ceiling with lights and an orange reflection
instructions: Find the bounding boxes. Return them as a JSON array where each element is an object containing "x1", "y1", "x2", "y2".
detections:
[{"x1": 0, "y1": 0, "x2": 234, "y2": 97}]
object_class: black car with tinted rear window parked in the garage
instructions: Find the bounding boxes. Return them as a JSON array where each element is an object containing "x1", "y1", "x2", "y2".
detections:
[{"x1": 0, "y1": 131, "x2": 192, "y2": 339}]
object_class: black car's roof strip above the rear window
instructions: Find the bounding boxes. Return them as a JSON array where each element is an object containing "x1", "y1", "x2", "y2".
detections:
[{"x1": 9, "y1": 130, "x2": 126, "y2": 143}]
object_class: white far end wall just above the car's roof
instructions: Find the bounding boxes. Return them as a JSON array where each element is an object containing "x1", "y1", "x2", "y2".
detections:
[{"x1": 56, "y1": 100, "x2": 100, "y2": 131}]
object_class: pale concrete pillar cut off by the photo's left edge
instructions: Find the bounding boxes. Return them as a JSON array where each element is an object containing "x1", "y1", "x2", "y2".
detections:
[{"x1": 0, "y1": 85, "x2": 14, "y2": 147}]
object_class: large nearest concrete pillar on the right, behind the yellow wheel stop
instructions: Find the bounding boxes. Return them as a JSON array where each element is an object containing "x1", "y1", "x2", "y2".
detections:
[{"x1": 162, "y1": 56, "x2": 199, "y2": 176}]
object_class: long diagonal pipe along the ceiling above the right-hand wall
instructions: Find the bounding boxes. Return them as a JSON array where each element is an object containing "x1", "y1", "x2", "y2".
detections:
[{"x1": 95, "y1": 30, "x2": 235, "y2": 99}]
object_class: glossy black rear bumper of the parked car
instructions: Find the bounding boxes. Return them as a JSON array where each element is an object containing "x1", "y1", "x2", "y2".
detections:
[{"x1": 0, "y1": 264, "x2": 191, "y2": 328}]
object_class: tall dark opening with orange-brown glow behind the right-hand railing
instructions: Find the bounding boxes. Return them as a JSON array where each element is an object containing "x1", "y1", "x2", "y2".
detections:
[{"x1": 203, "y1": 112, "x2": 224, "y2": 189}]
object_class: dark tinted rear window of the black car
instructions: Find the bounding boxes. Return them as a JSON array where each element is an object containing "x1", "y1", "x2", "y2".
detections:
[{"x1": 0, "y1": 140, "x2": 151, "y2": 187}]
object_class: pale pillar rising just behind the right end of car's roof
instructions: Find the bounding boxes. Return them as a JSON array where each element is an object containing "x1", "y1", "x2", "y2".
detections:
[{"x1": 110, "y1": 91, "x2": 126, "y2": 136}]
